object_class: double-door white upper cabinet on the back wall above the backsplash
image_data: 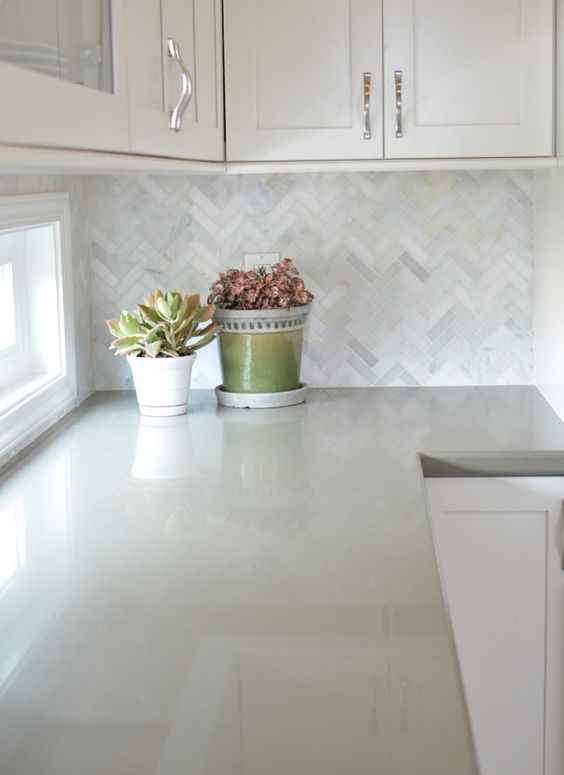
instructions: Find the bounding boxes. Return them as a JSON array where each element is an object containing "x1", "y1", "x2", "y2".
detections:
[{"x1": 224, "y1": 0, "x2": 554, "y2": 161}]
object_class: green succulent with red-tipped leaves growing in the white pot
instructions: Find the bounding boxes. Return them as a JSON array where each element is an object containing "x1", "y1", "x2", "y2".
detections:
[{"x1": 106, "y1": 288, "x2": 219, "y2": 358}]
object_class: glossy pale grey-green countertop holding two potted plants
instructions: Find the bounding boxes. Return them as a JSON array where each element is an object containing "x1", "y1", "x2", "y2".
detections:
[{"x1": 0, "y1": 387, "x2": 564, "y2": 775}]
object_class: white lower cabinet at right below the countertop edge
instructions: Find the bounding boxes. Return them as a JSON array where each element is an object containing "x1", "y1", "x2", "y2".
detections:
[{"x1": 426, "y1": 477, "x2": 564, "y2": 775}]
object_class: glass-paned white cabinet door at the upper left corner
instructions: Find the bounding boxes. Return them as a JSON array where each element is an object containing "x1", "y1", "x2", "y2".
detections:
[{"x1": 0, "y1": 0, "x2": 129, "y2": 151}]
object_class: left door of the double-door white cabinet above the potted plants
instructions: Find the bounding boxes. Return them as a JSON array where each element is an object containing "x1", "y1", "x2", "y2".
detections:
[{"x1": 224, "y1": 0, "x2": 382, "y2": 161}]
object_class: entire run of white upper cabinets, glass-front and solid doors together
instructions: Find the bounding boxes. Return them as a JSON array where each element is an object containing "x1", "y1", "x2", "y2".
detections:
[{"x1": 0, "y1": 0, "x2": 554, "y2": 163}]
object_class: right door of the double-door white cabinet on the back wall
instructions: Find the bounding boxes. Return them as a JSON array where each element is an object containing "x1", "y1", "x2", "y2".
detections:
[{"x1": 384, "y1": 0, "x2": 554, "y2": 159}]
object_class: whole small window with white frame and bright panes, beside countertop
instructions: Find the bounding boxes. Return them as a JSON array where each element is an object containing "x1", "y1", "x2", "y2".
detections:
[{"x1": 0, "y1": 193, "x2": 76, "y2": 460}]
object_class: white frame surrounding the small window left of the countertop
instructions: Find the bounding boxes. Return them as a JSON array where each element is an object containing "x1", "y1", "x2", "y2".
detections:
[{"x1": 0, "y1": 192, "x2": 77, "y2": 462}]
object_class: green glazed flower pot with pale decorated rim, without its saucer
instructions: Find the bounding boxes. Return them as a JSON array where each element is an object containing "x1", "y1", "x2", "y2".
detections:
[{"x1": 214, "y1": 304, "x2": 310, "y2": 393}]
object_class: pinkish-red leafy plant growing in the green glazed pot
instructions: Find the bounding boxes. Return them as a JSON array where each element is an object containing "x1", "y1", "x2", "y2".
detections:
[{"x1": 208, "y1": 258, "x2": 313, "y2": 309}]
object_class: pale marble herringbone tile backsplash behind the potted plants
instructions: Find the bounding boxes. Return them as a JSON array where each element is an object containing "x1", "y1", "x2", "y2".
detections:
[{"x1": 88, "y1": 171, "x2": 533, "y2": 388}]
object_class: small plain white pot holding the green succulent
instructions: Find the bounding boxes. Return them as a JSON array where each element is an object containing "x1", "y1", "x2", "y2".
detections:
[{"x1": 127, "y1": 353, "x2": 196, "y2": 417}]
